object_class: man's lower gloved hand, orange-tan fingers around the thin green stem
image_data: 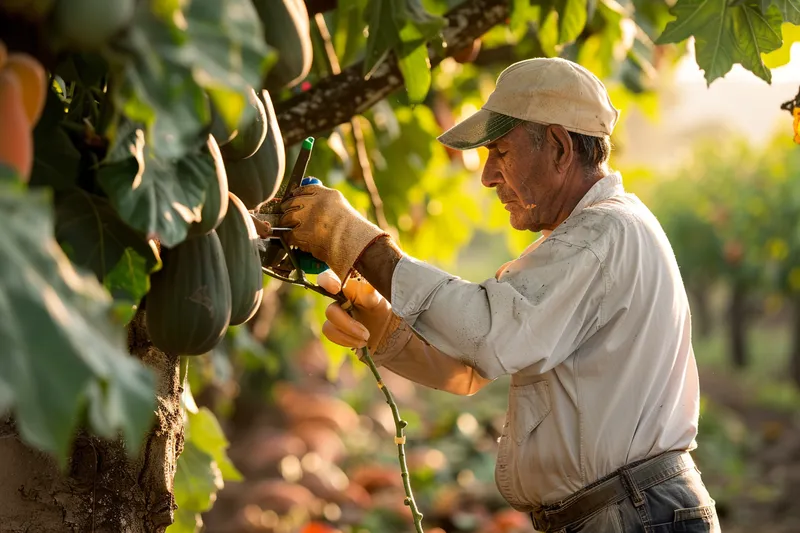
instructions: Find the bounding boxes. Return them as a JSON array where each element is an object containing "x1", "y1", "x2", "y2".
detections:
[{"x1": 317, "y1": 270, "x2": 400, "y2": 354}]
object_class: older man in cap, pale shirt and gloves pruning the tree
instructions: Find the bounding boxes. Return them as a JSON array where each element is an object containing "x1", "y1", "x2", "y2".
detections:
[{"x1": 281, "y1": 58, "x2": 719, "y2": 533}]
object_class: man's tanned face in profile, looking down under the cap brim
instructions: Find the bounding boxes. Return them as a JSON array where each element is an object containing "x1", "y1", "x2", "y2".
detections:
[{"x1": 481, "y1": 125, "x2": 576, "y2": 231}]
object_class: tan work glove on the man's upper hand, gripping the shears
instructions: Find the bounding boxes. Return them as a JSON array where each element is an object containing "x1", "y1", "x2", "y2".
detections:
[{"x1": 280, "y1": 185, "x2": 388, "y2": 280}]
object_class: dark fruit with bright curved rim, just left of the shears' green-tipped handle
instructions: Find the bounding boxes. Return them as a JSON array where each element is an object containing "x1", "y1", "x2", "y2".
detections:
[{"x1": 225, "y1": 90, "x2": 286, "y2": 209}]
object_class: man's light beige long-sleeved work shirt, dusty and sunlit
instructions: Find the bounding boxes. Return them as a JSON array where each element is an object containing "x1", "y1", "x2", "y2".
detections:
[{"x1": 375, "y1": 173, "x2": 699, "y2": 512}]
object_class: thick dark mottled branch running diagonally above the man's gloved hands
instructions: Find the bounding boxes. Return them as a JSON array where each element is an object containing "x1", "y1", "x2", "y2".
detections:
[{"x1": 276, "y1": 0, "x2": 509, "y2": 146}]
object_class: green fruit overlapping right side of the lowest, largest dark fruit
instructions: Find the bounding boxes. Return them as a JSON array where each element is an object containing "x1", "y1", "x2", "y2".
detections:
[{"x1": 217, "y1": 193, "x2": 264, "y2": 326}]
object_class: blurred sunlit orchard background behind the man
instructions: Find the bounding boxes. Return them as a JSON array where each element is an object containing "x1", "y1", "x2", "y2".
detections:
[{"x1": 183, "y1": 32, "x2": 800, "y2": 533}]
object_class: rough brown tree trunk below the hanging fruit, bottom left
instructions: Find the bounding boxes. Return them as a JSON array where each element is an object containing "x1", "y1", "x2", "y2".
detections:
[{"x1": 0, "y1": 310, "x2": 183, "y2": 533}]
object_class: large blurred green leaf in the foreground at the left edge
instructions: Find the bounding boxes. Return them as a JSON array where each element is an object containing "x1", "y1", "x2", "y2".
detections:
[{"x1": 0, "y1": 185, "x2": 155, "y2": 462}]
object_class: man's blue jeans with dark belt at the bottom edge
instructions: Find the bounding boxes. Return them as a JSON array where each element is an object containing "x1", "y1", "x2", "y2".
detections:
[{"x1": 531, "y1": 452, "x2": 721, "y2": 533}]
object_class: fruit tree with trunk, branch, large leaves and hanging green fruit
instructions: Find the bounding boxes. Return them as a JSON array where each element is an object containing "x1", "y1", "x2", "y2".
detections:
[{"x1": 0, "y1": 0, "x2": 800, "y2": 532}]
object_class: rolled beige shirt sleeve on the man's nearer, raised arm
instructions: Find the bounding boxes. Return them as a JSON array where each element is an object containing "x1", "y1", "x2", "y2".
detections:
[{"x1": 392, "y1": 237, "x2": 607, "y2": 380}]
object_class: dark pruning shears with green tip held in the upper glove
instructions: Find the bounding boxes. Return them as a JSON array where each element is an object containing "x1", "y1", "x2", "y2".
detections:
[{"x1": 259, "y1": 137, "x2": 329, "y2": 278}]
